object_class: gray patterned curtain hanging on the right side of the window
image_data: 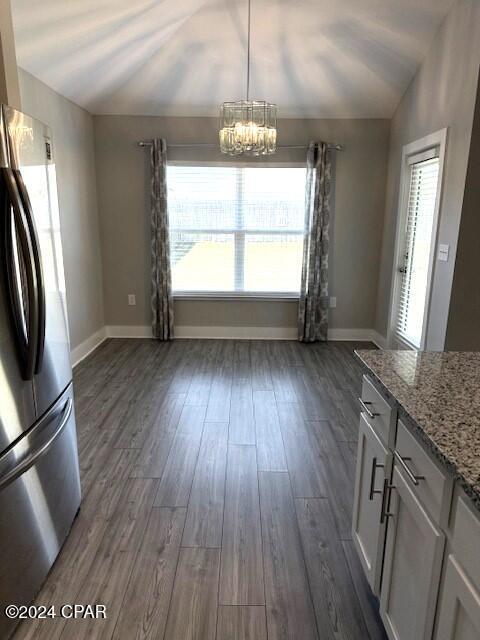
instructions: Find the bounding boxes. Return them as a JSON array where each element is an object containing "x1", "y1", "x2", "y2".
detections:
[{"x1": 298, "y1": 142, "x2": 331, "y2": 342}]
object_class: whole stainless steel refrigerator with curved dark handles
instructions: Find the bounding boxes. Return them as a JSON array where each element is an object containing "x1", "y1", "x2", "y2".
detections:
[{"x1": 0, "y1": 105, "x2": 80, "y2": 638}]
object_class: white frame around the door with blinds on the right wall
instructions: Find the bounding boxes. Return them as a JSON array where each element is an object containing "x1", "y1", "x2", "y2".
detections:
[{"x1": 387, "y1": 128, "x2": 448, "y2": 351}]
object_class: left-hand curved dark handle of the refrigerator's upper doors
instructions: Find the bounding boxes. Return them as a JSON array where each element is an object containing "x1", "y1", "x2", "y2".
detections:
[{"x1": 1, "y1": 167, "x2": 39, "y2": 380}]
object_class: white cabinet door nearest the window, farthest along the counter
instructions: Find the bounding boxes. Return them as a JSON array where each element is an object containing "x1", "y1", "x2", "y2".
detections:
[{"x1": 352, "y1": 415, "x2": 391, "y2": 594}]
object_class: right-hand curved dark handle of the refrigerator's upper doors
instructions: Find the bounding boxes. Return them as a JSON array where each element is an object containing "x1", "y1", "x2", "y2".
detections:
[{"x1": 13, "y1": 169, "x2": 46, "y2": 373}]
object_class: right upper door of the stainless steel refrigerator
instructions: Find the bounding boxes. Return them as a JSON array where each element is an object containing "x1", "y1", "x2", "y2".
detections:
[{"x1": 3, "y1": 106, "x2": 72, "y2": 416}]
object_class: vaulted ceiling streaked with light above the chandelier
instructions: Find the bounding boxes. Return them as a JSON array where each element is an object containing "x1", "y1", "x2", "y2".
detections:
[{"x1": 12, "y1": 0, "x2": 454, "y2": 118}]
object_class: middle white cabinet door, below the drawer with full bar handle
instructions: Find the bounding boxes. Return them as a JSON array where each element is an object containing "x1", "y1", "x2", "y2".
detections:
[{"x1": 380, "y1": 469, "x2": 445, "y2": 640}]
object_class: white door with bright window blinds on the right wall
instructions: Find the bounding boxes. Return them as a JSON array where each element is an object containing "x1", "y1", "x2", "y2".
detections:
[{"x1": 391, "y1": 147, "x2": 440, "y2": 349}]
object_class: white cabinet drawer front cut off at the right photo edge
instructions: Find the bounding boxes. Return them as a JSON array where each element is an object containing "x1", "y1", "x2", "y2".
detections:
[{"x1": 452, "y1": 497, "x2": 480, "y2": 591}]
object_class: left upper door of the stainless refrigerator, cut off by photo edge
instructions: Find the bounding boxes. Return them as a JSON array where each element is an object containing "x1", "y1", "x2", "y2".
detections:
[{"x1": 0, "y1": 109, "x2": 35, "y2": 455}]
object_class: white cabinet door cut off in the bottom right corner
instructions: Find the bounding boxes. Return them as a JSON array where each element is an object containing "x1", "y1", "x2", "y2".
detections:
[{"x1": 435, "y1": 555, "x2": 480, "y2": 640}]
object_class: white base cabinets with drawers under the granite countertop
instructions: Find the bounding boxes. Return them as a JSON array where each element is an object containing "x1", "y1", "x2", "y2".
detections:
[{"x1": 352, "y1": 376, "x2": 480, "y2": 640}]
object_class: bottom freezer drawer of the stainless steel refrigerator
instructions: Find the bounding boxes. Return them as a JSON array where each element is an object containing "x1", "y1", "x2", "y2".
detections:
[{"x1": 0, "y1": 385, "x2": 80, "y2": 638}]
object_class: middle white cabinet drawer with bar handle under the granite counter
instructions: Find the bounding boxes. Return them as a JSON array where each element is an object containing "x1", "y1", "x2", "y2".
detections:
[{"x1": 395, "y1": 420, "x2": 453, "y2": 525}]
